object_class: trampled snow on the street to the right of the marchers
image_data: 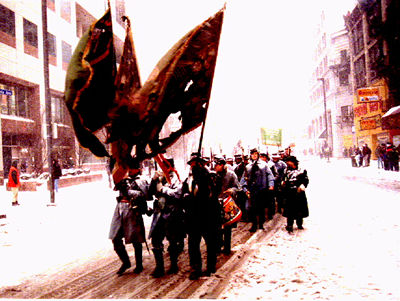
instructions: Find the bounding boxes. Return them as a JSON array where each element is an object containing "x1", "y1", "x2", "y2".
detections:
[{"x1": 220, "y1": 161, "x2": 400, "y2": 300}]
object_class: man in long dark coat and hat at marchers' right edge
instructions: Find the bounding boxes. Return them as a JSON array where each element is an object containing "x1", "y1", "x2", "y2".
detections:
[{"x1": 282, "y1": 156, "x2": 309, "y2": 233}]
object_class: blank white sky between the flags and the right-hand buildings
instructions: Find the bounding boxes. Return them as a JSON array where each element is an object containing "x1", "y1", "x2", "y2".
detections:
[{"x1": 126, "y1": 0, "x2": 356, "y2": 150}]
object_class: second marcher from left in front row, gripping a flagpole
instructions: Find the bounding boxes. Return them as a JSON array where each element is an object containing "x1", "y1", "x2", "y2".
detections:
[{"x1": 149, "y1": 159, "x2": 186, "y2": 278}]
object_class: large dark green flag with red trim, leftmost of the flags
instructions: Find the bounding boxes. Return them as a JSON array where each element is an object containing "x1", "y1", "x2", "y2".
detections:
[{"x1": 65, "y1": 9, "x2": 116, "y2": 157}]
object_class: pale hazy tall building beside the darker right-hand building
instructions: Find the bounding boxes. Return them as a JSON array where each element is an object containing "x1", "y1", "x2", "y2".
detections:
[{"x1": 306, "y1": 10, "x2": 354, "y2": 157}]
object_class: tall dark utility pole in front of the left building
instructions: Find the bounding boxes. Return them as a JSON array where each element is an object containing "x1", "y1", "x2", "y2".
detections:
[{"x1": 42, "y1": 0, "x2": 54, "y2": 205}]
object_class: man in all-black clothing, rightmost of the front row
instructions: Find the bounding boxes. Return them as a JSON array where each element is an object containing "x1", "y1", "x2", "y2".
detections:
[{"x1": 182, "y1": 153, "x2": 221, "y2": 280}]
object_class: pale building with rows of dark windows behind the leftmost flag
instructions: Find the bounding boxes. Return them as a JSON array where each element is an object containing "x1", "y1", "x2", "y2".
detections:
[{"x1": 0, "y1": 0, "x2": 125, "y2": 183}]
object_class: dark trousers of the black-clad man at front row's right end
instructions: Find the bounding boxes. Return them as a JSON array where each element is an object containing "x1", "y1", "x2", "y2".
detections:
[{"x1": 188, "y1": 225, "x2": 218, "y2": 272}]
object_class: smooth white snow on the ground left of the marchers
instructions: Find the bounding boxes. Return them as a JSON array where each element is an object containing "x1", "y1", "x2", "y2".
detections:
[{"x1": 0, "y1": 172, "x2": 116, "y2": 287}]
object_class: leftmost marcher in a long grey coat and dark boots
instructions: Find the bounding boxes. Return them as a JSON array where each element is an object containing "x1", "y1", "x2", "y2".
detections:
[{"x1": 109, "y1": 159, "x2": 149, "y2": 275}]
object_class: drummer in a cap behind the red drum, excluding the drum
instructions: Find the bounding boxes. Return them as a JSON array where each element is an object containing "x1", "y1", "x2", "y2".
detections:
[{"x1": 215, "y1": 159, "x2": 239, "y2": 255}]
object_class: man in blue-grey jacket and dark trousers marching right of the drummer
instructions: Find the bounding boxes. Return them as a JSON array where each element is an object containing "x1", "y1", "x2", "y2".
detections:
[{"x1": 242, "y1": 148, "x2": 274, "y2": 232}]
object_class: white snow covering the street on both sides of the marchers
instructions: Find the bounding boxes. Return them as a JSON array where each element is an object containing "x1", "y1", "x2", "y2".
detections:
[{"x1": 0, "y1": 159, "x2": 400, "y2": 300}]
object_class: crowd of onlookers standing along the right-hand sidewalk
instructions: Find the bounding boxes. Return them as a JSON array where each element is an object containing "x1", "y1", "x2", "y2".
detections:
[{"x1": 343, "y1": 142, "x2": 400, "y2": 171}]
